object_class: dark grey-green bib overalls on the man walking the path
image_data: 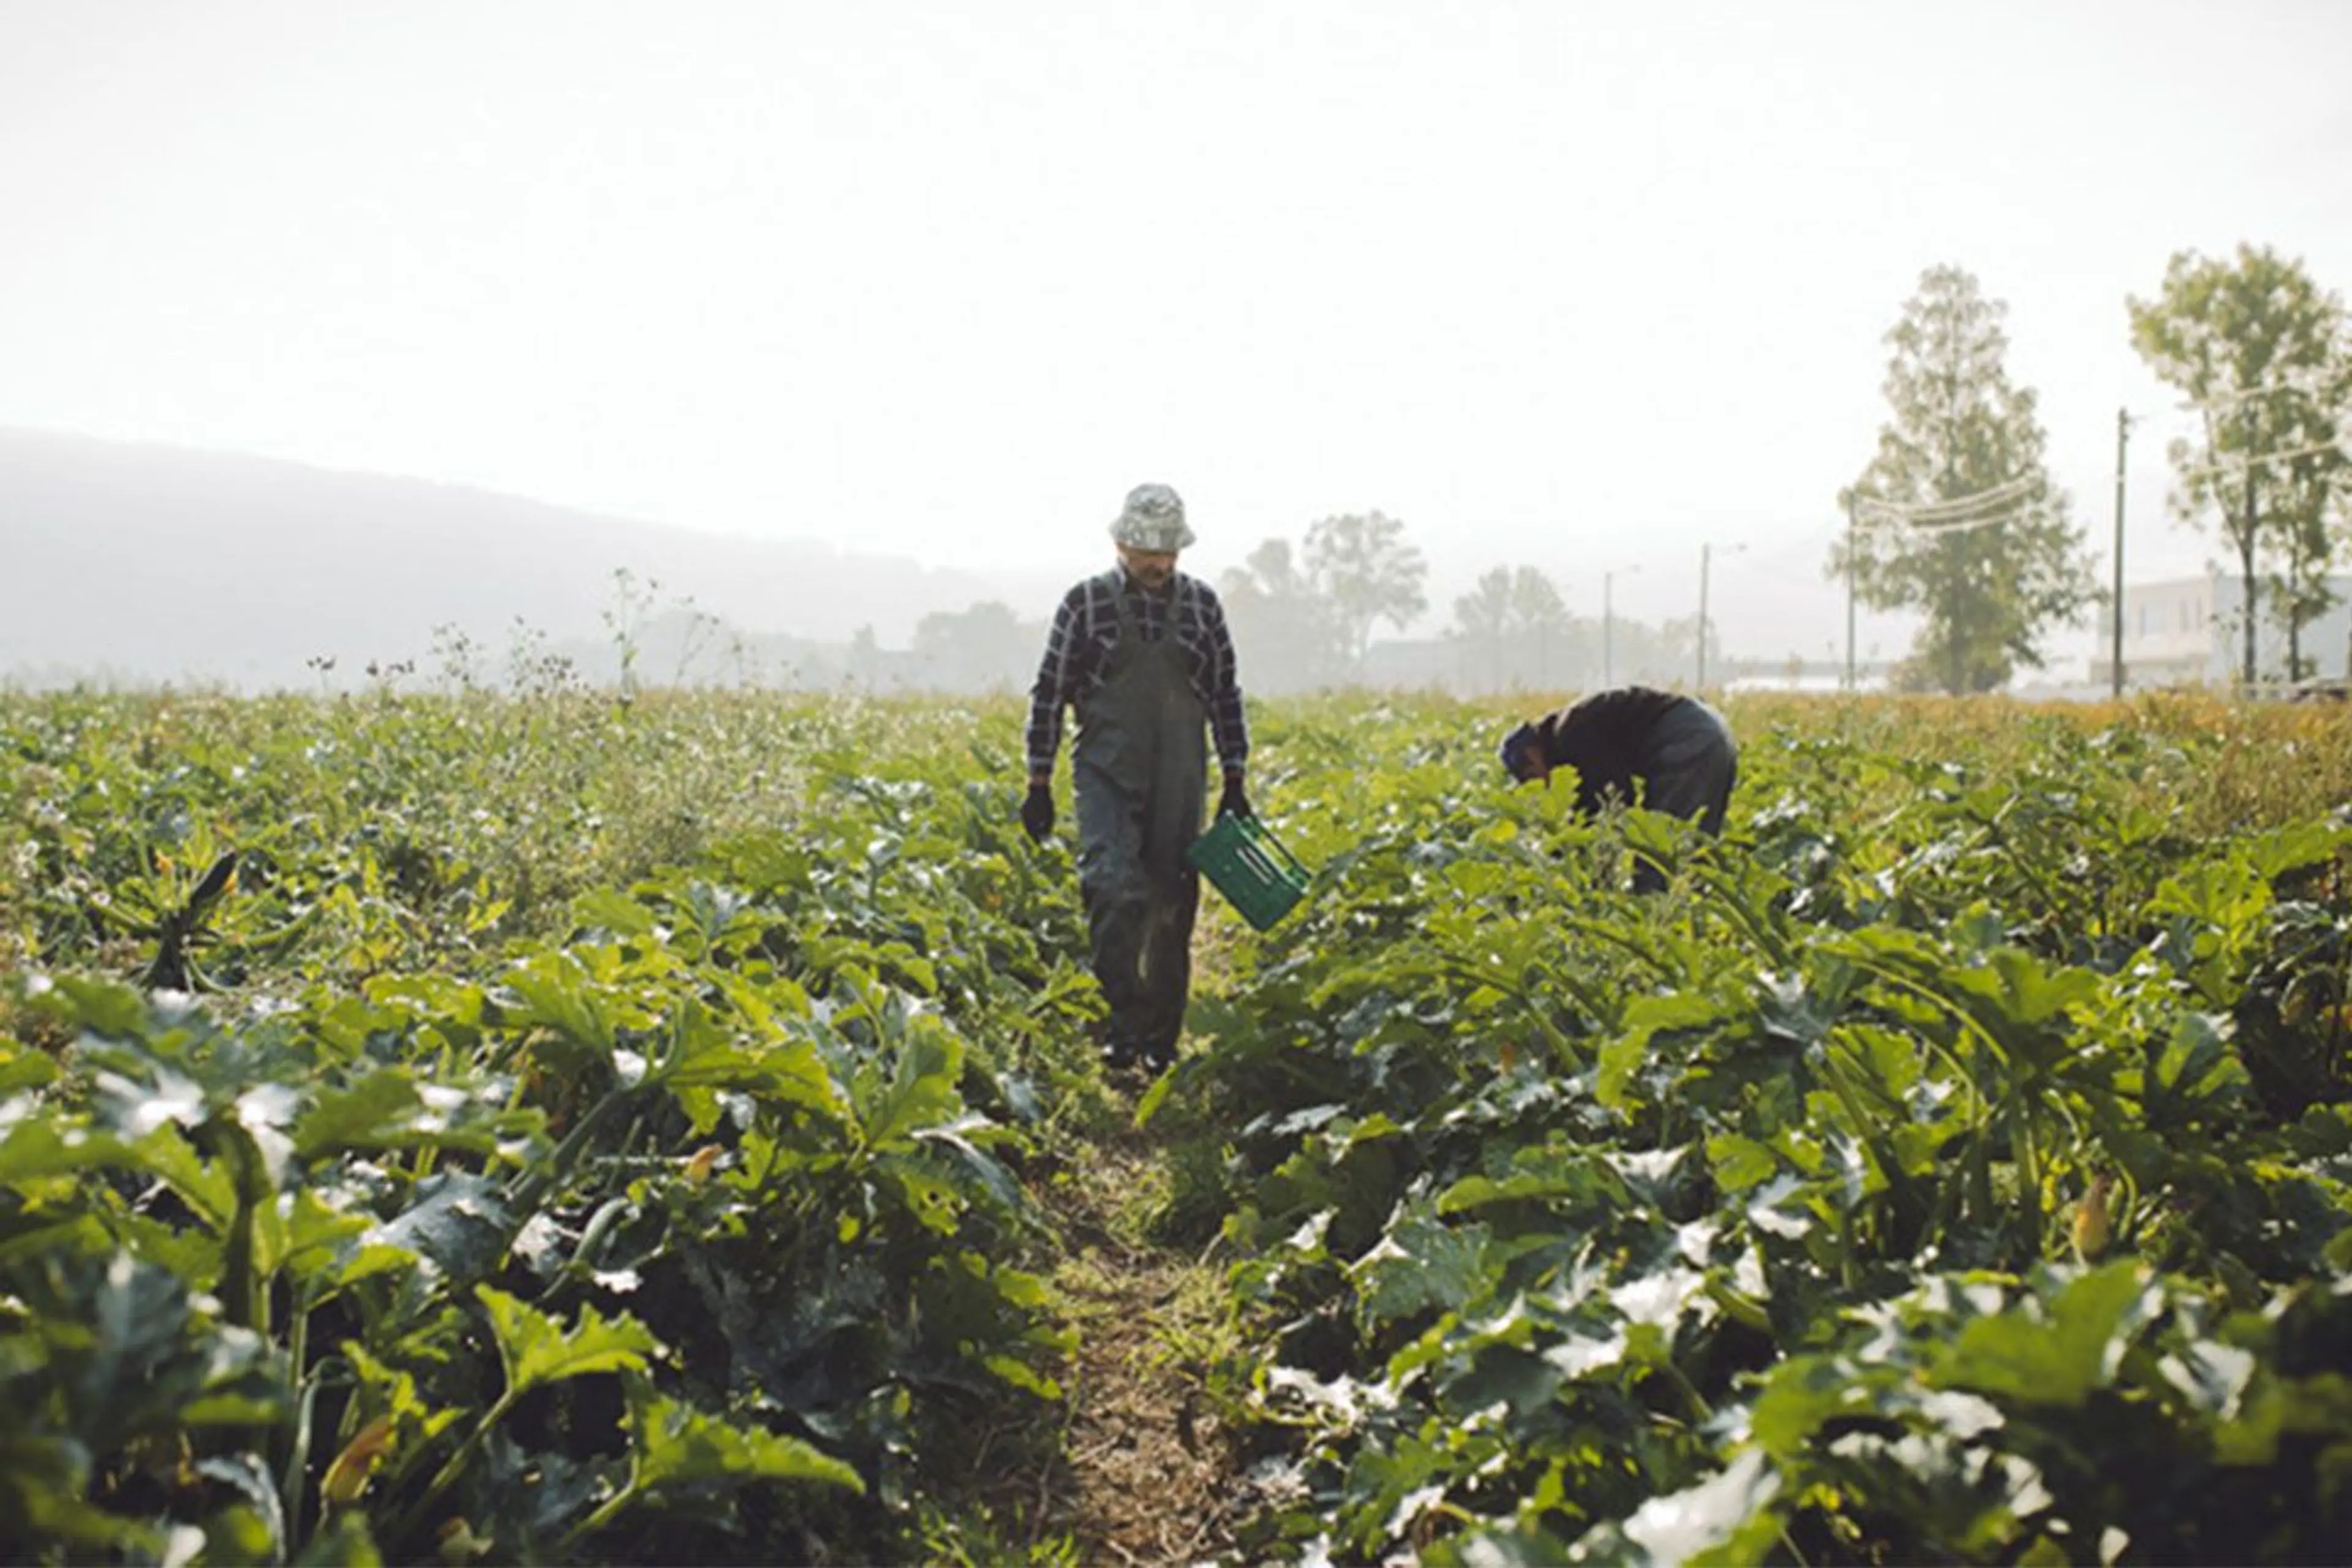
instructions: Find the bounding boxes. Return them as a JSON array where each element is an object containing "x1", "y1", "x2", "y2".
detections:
[{"x1": 1070, "y1": 583, "x2": 1209, "y2": 1065}]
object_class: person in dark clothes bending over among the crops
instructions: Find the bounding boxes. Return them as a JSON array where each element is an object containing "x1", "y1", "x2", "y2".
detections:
[{"x1": 1503, "y1": 687, "x2": 1741, "y2": 889}]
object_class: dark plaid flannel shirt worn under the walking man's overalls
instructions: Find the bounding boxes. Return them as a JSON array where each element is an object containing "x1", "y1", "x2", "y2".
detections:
[{"x1": 1028, "y1": 567, "x2": 1249, "y2": 780}]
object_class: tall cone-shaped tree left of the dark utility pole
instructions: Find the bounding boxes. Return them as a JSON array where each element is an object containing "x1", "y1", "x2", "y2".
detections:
[{"x1": 1830, "y1": 266, "x2": 2095, "y2": 693}]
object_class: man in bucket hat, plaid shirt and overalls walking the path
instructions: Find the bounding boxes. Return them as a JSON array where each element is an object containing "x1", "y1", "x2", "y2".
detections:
[{"x1": 1021, "y1": 484, "x2": 1249, "y2": 1067}]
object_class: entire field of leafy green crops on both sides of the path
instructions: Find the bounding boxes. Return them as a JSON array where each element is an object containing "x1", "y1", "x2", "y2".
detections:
[{"x1": 0, "y1": 689, "x2": 2352, "y2": 1566}]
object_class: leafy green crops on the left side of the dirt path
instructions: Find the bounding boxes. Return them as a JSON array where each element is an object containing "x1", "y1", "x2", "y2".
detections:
[{"x1": 0, "y1": 703, "x2": 1094, "y2": 1561}]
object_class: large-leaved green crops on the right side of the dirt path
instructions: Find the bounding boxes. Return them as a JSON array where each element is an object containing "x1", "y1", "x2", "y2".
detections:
[{"x1": 1190, "y1": 717, "x2": 2352, "y2": 1563}]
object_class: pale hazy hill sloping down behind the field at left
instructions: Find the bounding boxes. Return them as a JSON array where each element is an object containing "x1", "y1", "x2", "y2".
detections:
[{"x1": 0, "y1": 428, "x2": 1061, "y2": 689}]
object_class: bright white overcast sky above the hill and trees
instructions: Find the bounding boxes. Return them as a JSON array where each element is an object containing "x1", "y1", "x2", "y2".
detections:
[{"x1": 0, "y1": 0, "x2": 2352, "y2": 649}]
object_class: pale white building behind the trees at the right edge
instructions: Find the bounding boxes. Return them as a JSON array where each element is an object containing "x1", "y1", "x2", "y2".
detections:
[{"x1": 2091, "y1": 569, "x2": 2352, "y2": 687}]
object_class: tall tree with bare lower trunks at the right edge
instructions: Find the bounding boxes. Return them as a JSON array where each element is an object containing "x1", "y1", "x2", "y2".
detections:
[{"x1": 2126, "y1": 244, "x2": 2352, "y2": 682}]
